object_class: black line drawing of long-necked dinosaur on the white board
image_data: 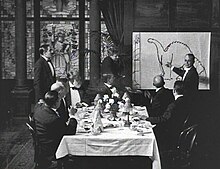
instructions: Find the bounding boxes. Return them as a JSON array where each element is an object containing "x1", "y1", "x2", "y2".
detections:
[{"x1": 147, "y1": 38, "x2": 207, "y2": 80}]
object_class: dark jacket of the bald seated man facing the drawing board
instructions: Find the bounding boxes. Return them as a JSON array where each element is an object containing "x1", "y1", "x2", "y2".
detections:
[{"x1": 148, "y1": 87, "x2": 174, "y2": 117}]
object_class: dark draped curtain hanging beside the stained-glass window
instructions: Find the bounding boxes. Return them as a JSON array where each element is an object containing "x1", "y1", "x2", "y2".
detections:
[{"x1": 99, "y1": 0, "x2": 124, "y2": 52}]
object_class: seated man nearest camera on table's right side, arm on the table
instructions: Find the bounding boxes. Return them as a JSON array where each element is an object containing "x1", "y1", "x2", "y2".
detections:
[{"x1": 146, "y1": 81, "x2": 189, "y2": 150}]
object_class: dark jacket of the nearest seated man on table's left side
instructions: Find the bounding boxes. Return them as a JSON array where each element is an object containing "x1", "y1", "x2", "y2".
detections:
[{"x1": 33, "y1": 104, "x2": 76, "y2": 162}]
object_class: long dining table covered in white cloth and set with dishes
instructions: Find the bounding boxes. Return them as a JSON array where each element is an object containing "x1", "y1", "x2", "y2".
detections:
[{"x1": 56, "y1": 106, "x2": 161, "y2": 169}]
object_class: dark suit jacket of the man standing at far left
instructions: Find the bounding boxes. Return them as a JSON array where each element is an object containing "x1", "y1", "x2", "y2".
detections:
[{"x1": 34, "y1": 57, "x2": 56, "y2": 102}]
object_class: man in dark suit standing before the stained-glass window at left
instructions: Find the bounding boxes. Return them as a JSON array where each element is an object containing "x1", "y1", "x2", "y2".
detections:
[{"x1": 34, "y1": 44, "x2": 56, "y2": 102}]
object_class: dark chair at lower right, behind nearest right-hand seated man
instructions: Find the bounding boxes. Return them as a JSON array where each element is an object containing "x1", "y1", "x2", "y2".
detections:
[{"x1": 161, "y1": 124, "x2": 198, "y2": 169}]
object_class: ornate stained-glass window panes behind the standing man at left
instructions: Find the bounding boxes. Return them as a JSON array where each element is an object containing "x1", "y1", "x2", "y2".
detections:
[{"x1": 0, "y1": 0, "x2": 107, "y2": 80}]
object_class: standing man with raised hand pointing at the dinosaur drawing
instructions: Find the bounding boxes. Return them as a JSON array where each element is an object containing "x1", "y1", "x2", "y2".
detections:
[{"x1": 166, "y1": 53, "x2": 199, "y2": 99}]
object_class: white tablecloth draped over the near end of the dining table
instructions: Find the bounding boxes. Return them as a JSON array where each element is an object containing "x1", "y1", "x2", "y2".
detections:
[{"x1": 56, "y1": 108, "x2": 161, "y2": 169}]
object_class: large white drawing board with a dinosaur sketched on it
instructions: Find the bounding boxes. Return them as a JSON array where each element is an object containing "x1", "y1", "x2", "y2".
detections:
[{"x1": 132, "y1": 32, "x2": 211, "y2": 89}]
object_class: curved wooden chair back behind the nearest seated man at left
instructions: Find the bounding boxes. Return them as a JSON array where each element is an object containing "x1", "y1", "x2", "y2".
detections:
[{"x1": 26, "y1": 123, "x2": 39, "y2": 169}]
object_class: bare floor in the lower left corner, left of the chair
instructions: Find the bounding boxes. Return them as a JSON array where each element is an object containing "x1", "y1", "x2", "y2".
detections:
[{"x1": 0, "y1": 119, "x2": 34, "y2": 169}]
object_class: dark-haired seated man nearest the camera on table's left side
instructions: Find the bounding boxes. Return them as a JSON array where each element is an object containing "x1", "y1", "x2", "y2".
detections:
[{"x1": 33, "y1": 91, "x2": 77, "y2": 169}]
